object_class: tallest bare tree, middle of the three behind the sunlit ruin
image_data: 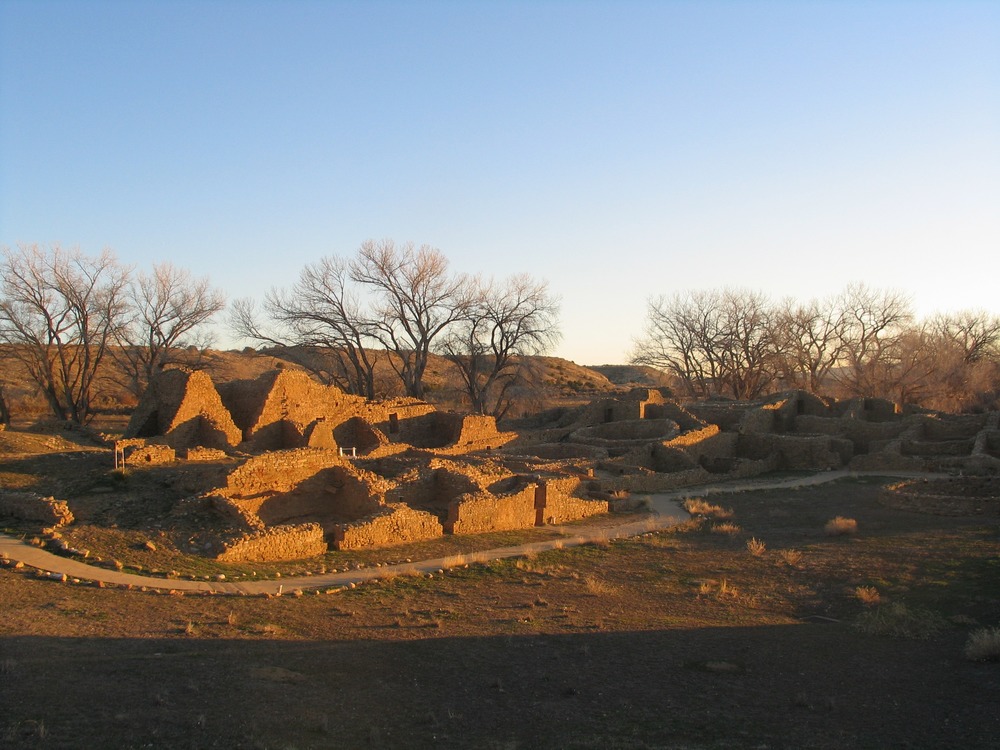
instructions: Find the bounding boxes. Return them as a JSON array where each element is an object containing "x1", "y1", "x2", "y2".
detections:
[{"x1": 350, "y1": 240, "x2": 470, "y2": 398}]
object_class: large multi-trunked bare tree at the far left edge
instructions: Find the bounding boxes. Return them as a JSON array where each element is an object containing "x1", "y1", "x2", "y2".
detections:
[{"x1": 0, "y1": 245, "x2": 129, "y2": 424}]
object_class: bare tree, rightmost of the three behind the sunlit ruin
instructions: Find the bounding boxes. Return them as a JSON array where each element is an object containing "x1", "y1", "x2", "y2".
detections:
[{"x1": 443, "y1": 274, "x2": 559, "y2": 417}]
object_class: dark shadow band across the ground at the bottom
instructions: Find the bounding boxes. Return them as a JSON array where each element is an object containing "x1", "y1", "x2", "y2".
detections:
[{"x1": 0, "y1": 624, "x2": 1000, "y2": 748}]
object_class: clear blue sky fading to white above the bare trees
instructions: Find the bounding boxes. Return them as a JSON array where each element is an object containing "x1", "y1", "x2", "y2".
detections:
[{"x1": 0, "y1": 0, "x2": 1000, "y2": 364}]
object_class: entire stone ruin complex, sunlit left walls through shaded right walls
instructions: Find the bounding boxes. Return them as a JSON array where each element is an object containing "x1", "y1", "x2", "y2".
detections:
[{"x1": 113, "y1": 369, "x2": 1000, "y2": 560}]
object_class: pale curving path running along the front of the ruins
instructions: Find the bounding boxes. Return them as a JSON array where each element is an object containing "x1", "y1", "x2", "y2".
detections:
[{"x1": 0, "y1": 470, "x2": 948, "y2": 595}]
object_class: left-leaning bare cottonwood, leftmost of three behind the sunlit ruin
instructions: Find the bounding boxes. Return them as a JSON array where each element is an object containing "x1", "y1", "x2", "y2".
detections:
[{"x1": 230, "y1": 257, "x2": 378, "y2": 398}]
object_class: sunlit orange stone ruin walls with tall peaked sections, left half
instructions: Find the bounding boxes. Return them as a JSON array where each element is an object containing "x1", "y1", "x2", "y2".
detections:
[{"x1": 123, "y1": 369, "x2": 608, "y2": 560}]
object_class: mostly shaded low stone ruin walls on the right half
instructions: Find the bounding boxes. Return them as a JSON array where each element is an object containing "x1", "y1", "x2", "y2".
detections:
[{"x1": 505, "y1": 389, "x2": 1000, "y2": 500}]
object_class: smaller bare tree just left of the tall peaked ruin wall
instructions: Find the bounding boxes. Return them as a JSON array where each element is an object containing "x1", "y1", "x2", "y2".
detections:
[{"x1": 112, "y1": 263, "x2": 226, "y2": 396}]
